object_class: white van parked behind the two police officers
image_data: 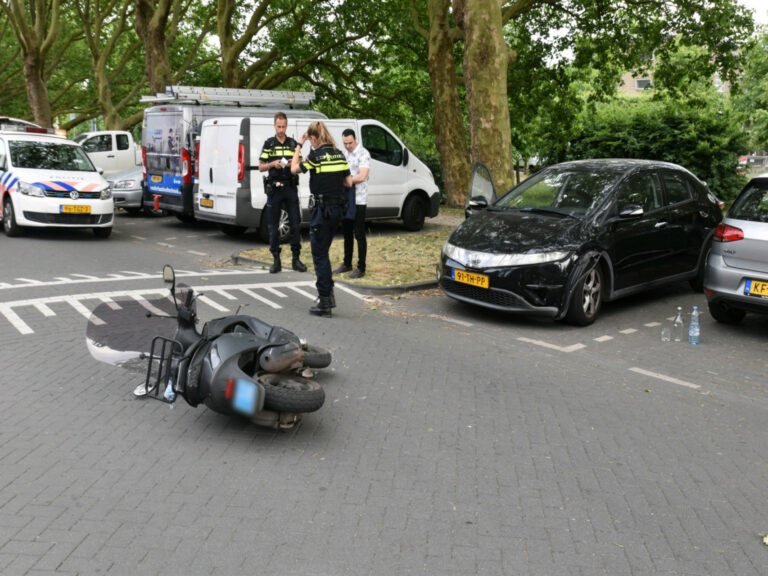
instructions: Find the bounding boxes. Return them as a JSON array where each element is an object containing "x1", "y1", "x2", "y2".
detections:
[{"x1": 194, "y1": 112, "x2": 440, "y2": 241}]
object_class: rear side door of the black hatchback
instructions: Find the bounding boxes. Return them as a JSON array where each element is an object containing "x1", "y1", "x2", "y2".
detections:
[{"x1": 660, "y1": 168, "x2": 704, "y2": 276}]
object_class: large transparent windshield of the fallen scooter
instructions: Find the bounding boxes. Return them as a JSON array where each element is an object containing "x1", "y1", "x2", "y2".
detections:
[{"x1": 85, "y1": 291, "x2": 177, "y2": 374}]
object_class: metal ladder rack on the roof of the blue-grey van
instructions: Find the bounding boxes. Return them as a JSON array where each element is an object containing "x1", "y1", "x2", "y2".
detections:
[{"x1": 141, "y1": 86, "x2": 315, "y2": 108}]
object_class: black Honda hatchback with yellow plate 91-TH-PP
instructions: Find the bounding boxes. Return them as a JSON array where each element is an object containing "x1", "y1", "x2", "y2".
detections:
[{"x1": 438, "y1": 159, "x2": 722, "y2": 326}]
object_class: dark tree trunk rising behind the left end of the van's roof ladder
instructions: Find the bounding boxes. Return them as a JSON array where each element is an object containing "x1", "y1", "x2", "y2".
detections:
[{"x1": 134, "y1": 0, "x2": 172, "y2": 94}]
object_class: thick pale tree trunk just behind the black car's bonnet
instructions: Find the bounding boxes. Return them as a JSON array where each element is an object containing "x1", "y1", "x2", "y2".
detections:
[{"x1": 454, "y1": 0, "x2": 513, "y2": 194}]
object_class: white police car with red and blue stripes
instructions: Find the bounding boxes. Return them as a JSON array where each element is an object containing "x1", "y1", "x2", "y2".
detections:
[{"x1": 0, "y1": 125, "x2": 115, "y2": 238}]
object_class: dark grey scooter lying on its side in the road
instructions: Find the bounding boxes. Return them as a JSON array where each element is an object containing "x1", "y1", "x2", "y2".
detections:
[{"x1": 86, "y1": 265, "x2": 331, "y2": 428}]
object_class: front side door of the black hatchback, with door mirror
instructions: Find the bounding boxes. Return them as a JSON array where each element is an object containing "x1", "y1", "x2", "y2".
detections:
[{"x1": 610, "y1": 170, "x2": 669, "y2": 290}]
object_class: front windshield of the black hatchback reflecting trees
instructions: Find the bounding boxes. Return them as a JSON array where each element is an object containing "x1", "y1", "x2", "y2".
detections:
[{"x1": 494, "y1": 166, "x2": 626, "y2": 216}]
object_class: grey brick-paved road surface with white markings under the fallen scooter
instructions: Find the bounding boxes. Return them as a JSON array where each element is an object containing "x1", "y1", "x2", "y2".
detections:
[{"x1": 0, "y1": 215, "x2": 768, "y2": 576}]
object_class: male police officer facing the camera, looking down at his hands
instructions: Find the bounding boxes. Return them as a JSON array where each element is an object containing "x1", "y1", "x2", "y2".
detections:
[{"x1": 259, "y1": 112, "x2": 307, "y2": 274}]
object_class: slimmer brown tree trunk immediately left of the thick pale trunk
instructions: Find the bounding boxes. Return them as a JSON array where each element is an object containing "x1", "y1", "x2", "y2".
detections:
[{"x1": 428, "y1": 0, "x2": 470, "y2": 206}]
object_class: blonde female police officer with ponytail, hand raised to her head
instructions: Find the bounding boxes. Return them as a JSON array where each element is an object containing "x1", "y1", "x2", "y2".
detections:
[{"x1": 291, "y1": 122, "x2": 352, "y2": 316}]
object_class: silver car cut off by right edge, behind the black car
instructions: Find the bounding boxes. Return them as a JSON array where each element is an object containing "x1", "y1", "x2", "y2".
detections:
[{"x1": 704, "y1": 173, "x2": 768, "y2": 324}]
